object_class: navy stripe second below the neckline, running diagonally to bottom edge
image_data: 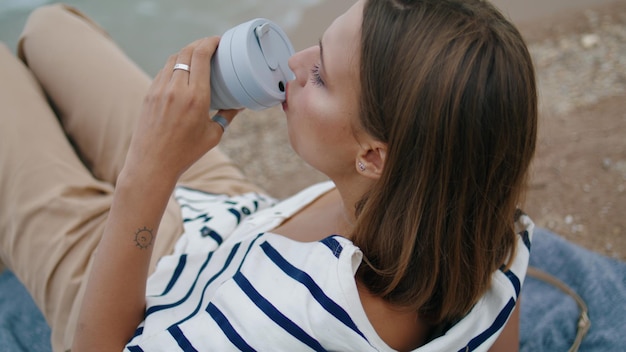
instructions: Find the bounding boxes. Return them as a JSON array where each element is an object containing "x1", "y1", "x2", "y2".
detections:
[{"x1": 233, "y1": 272, "x2": 326, "y2": 351}]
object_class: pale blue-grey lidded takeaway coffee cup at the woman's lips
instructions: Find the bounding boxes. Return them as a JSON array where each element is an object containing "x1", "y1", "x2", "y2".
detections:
[{"x1": 211, "y1": 18, "x2": 295, "y2": 110}]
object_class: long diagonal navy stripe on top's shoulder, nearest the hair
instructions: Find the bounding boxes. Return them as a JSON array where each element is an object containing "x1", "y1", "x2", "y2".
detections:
[{"x1": 261, "y1": 242, "x2": 367, "y2": 341}]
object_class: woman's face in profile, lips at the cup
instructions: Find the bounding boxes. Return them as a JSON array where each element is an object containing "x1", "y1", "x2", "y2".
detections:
[{"x1": 283, "y1": 0, "x2": 364, "y2": 178}]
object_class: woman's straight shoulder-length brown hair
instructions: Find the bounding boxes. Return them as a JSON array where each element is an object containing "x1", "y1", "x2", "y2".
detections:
[{"x1": 352, "y1": 0, "x2": 537, "y2": 324}]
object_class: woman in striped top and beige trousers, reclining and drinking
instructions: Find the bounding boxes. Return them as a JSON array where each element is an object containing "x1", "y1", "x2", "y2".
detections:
[{"x1": 0, "y1": 0, "x2": 536, "y2": 351}]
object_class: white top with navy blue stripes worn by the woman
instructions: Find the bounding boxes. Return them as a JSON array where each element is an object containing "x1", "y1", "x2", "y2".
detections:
[{"x1": 125, "y1": 182, "x2": 533, "y2": 352}]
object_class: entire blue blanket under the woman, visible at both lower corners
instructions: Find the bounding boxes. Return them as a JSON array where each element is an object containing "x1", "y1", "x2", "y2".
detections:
[{"x1": 0, "y1": 229, "x2": 626, "y2": 352}]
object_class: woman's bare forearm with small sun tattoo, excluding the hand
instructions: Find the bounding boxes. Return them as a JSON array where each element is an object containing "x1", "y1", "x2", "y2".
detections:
[{"x1": 74, "y1": 169, "x2": 174, "y2": 351}]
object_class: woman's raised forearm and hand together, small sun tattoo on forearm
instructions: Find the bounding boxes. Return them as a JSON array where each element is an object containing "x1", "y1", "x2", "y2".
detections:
[{"x1": 74, "y1": 37, "x2": 232, "y2": 351}]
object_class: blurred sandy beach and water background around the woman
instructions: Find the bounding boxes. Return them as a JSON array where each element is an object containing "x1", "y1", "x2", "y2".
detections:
[{"x1": 0, "y1": 0, "x2": 626, "y2": 259}]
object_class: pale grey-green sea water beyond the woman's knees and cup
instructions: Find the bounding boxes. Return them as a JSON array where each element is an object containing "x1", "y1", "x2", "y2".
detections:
[{"x1": 0, "y1": 0, "x2": 326, "y2": 74}]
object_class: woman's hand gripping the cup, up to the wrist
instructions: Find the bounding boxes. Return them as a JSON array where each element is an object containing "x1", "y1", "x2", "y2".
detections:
[{"x1": 124, "y1": 37, "x2": 238, "y2": 182}]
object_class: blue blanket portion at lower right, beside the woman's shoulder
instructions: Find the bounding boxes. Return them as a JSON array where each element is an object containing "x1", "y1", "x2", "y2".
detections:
[{"x1": 520, "y1": 229, "x2": 626, "y2": 352}]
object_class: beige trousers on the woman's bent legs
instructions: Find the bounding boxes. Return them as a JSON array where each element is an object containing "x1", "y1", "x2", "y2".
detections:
[{"x1": 0, "y1": 5, "x2": 260, "y2": 351}]
